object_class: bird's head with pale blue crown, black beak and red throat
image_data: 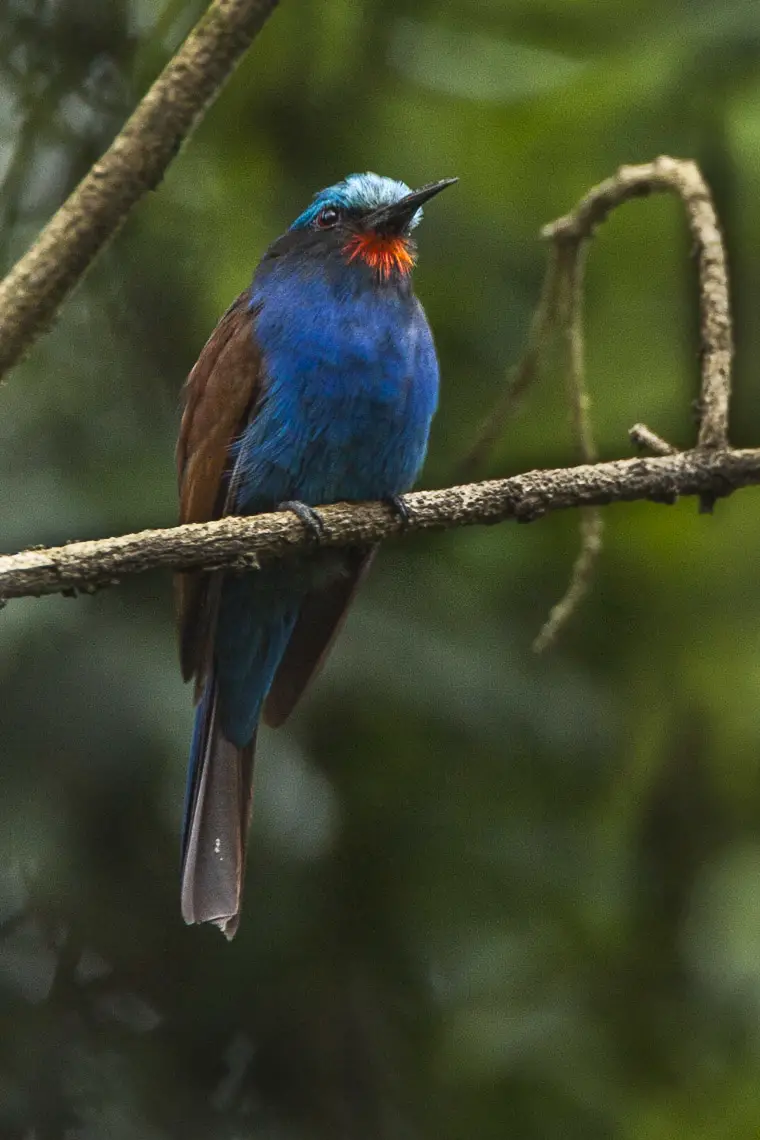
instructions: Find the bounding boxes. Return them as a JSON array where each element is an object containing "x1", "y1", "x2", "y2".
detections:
[{"x1": 281, "y1": 173, "x2": 457, "y2": 280}]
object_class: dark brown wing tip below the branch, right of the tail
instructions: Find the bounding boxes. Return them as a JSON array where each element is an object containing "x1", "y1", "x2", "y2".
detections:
[{"x1": 263, "y1": 546, "x2": 377, "y2": 728}]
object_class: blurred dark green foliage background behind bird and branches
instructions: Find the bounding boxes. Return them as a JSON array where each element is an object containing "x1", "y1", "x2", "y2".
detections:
[{"x1": 0, "y1": 0, "x2": 760, "y2": 1140}]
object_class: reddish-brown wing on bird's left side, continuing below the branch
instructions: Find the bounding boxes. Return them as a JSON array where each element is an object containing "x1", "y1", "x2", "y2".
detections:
[{"x1": 174, "y1": 291, "x2": 261, "y2": 685}]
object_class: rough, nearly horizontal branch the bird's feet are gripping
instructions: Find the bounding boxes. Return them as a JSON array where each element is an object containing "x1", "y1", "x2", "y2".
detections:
[{"x1": 0, "y1": 447, "x2": 760, "y2": 600}]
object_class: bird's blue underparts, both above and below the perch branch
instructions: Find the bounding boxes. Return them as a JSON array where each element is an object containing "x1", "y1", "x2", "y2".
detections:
[{"x1": 214, "y1": 260, "x2": 438, "y2": 747}]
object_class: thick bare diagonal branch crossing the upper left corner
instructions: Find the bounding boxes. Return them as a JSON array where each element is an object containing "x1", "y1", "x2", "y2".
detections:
[{"x1": 0, "y1": 0, "x2": 277, "y2": 376}]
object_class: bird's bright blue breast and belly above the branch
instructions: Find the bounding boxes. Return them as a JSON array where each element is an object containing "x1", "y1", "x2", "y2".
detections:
[{"x1": 236, "y1": 258, "x2": 439, "y2": 513}]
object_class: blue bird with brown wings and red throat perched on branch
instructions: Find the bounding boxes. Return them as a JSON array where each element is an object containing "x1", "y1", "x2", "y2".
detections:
[{"x1": 175, "y1": 172, "x2": 457, "y2": 938}]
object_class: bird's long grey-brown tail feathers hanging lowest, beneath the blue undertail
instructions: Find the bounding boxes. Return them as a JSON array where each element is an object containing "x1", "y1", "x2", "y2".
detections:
[{"x1": 182, "y1": 678, "x2": 256, "y2": 938}]
